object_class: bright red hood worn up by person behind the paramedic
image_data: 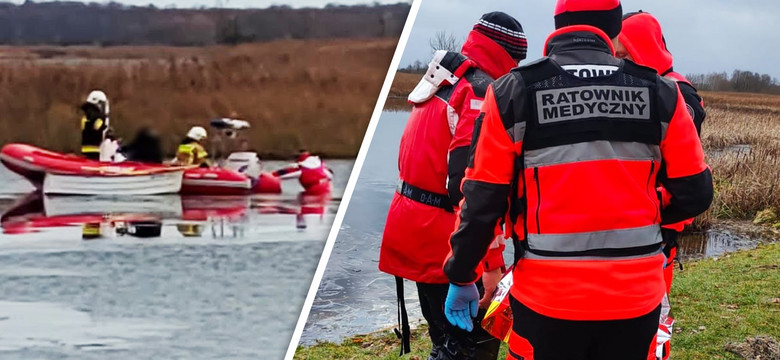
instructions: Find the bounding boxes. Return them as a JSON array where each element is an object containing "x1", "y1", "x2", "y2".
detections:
[{"x1": 618, "y1": 13, "x2": 673, "y2": 74}]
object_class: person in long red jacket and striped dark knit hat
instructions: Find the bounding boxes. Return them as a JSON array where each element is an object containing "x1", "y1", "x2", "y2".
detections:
[{"x1": 379, "y1": 12, "x2": 528, "y2": 360}]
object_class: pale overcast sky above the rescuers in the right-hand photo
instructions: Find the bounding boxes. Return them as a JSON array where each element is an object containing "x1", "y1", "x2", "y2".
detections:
[{"x1": 401, "y1": 0, "x2": 780, "y2": 78}]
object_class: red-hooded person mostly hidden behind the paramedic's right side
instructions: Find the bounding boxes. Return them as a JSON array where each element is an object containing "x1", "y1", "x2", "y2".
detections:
[{"x1": 615, "y1": 10, "x2": 707, "y2": 359}]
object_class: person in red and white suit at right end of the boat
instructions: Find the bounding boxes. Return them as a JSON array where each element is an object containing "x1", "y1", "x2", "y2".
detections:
[{"x1": 273, "y1": 150, "x2": 333, "y2": 195}]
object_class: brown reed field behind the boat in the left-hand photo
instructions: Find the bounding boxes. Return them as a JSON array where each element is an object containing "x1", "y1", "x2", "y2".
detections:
[{"x1": 0, "y1": 39, "x2": 397, "y2": 157}]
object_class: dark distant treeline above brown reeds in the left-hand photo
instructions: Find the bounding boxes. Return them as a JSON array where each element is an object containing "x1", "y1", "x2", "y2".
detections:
[{"x1": 0, "y1": 0, "x2": 410, "y2": 46}]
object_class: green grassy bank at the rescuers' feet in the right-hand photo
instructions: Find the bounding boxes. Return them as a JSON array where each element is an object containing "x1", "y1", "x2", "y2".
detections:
[{"x1": 295, "y1": 244, "x2": 780, "y2": 360}]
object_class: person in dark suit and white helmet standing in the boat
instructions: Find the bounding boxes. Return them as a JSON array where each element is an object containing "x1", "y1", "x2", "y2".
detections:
[{"x1": 81, "y1": 90, "x2": 109, "y2": 160}]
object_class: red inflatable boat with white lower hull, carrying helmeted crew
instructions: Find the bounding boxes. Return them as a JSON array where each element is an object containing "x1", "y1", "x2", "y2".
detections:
[{"x1": 0, "y1": 144, "x2": 282, "y2": 195}]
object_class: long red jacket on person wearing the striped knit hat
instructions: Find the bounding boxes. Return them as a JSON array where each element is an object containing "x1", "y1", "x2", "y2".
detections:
[{"x1": 379, "y1": 31, "x2": 517, "y2": 284}]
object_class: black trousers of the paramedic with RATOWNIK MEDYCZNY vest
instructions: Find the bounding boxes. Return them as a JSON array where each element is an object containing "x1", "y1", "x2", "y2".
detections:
[{"x1": 509, "y1": 298, "x2": 661, "y2": 360}]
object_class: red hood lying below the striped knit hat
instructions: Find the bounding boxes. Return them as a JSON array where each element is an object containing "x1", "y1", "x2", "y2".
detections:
[{"x1": 460, "y1": 30, "x2": 517, "y2": 79}]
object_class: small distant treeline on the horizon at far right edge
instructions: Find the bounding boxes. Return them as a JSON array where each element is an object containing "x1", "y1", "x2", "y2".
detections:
[{"x1": 687, "y1": 70, "x2": 780, "y2": 94}]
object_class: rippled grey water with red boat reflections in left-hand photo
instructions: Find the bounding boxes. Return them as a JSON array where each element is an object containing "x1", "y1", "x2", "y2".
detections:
[{"x1": 0, "y1": 160, "x2": 352, "y2": 360}]
